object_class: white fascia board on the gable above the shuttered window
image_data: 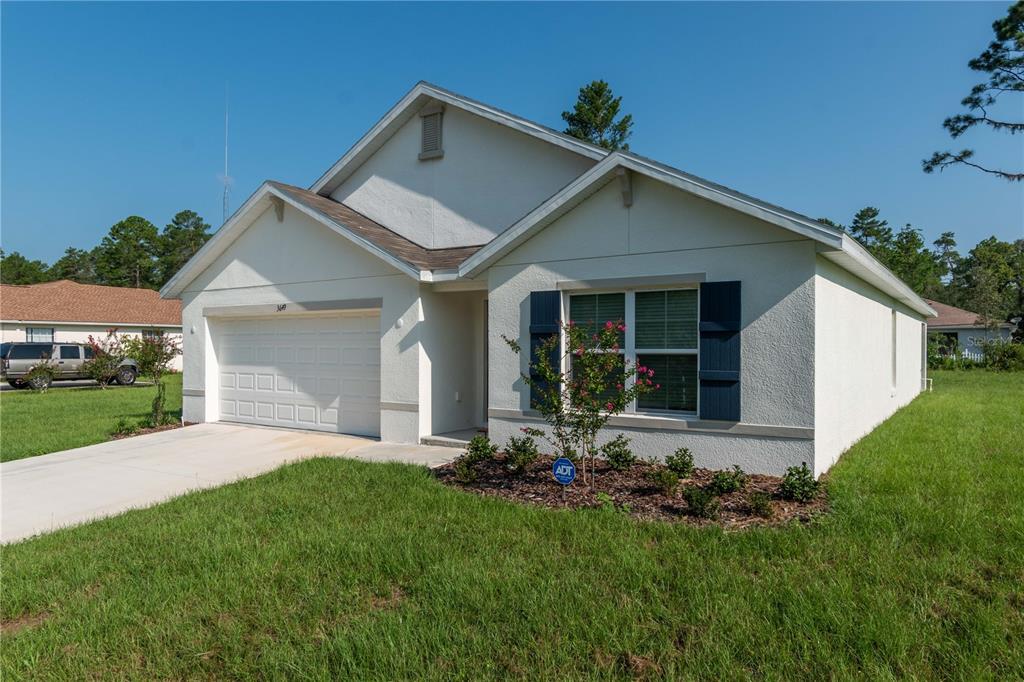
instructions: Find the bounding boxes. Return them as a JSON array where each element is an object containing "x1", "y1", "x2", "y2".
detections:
[{"x1": 459, "y1": 152, "x2": 843, "y2": 276}]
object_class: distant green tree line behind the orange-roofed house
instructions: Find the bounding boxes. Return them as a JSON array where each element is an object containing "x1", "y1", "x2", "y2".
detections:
[{"x1": 0, "y1": 211, "x2": 211, "y2": 289}]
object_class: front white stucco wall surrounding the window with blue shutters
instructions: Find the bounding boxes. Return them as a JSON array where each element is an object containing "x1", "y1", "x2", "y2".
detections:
[{"x1": 488, "y1": 177, "x2": 815, "y2": 473}]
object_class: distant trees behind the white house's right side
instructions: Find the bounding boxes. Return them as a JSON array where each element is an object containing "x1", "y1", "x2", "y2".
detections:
[{"x1": 818, "y1": 206, "x2": 1024, "y2": 323}]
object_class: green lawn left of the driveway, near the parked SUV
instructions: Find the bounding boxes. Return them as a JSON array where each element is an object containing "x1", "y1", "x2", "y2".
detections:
[{"x1": 0, "y1": 374, "x2": 181, "y2": 462}]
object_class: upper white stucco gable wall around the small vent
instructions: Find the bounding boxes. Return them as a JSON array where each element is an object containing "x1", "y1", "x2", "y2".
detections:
[{"x1": 331, "y1": 106, "x2": 595, "y2": 248}]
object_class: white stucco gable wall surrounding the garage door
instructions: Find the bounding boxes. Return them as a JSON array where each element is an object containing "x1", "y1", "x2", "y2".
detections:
[{"x1": 181, "y1": 202, "x2": 429, "y2": 442}]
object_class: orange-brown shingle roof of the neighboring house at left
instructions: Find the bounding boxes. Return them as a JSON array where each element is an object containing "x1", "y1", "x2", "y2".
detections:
[{"x1": 0, "y1": 280, "x2": 181, "y2": 327}]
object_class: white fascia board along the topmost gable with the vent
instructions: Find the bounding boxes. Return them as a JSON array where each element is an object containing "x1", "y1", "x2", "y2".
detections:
[{"x1": 309, "y1": 83, "x2": 608, "y2": 195}]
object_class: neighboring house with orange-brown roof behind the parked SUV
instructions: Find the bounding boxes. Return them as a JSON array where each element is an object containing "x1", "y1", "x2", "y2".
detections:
[{"x1": 0, "y1": 280, "x2": 182, "y2": 371}]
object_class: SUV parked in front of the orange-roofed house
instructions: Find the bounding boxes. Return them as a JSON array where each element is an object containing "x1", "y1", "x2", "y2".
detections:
[{"x1": 0, "y1": 342, "x2": 138, "y2": 389}]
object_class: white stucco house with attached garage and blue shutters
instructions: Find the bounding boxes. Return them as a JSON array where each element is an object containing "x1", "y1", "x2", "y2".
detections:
[{"x1": 162, "y1": 83, "x2": 935, "y2": 473}]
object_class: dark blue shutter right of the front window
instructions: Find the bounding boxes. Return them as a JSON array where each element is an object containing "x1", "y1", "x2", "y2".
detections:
[{"x1": 699, "y1": 282, "x2": 740, "y2": 422}]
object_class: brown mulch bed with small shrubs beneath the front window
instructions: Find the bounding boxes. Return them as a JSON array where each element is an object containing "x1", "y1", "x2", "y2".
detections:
[{"x1": 435, "y1": 455, "x2": 828, "y2": 529}]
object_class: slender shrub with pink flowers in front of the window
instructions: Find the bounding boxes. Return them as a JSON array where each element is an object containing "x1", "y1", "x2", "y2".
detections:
[{"x1": 505, "y1": 321, "x2": 660, "y2": 487}]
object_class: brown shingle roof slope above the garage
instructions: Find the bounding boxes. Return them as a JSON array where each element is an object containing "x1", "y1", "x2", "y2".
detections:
[{"x1": 268, "y1": 180, "x2": 480, "y2": 270}]
